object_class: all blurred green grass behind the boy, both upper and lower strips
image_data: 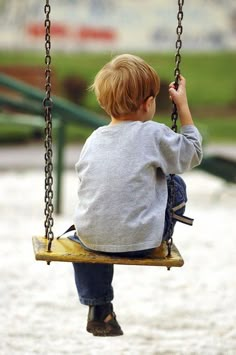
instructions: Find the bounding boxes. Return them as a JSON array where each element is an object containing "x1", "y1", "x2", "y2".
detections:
[{"x1": 0, "y1": 49, "x2": 236, "y2": 142}]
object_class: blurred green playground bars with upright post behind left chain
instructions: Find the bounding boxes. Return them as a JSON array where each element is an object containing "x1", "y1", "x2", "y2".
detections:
[{"x1": 0, "y1": 73, "x2": 107, "y2": 213}]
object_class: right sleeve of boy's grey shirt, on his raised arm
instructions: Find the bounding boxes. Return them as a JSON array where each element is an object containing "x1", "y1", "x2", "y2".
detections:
[{"x1": 158, "y1": 125, "x2": 203, "y2": 175}]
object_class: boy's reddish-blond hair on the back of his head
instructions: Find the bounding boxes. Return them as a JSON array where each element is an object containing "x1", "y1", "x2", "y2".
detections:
[{"x1": 91, "y1": 54, "x2": 160, "y2": 119}]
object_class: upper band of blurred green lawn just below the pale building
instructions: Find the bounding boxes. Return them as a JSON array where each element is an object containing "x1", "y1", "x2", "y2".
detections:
[{"x1": 0, "y1": 50, "x2": 236, "y2": 108}]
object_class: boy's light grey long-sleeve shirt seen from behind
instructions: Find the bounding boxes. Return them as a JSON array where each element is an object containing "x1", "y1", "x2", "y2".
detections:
[{"x1": 75, "y1": 121, "x2": 202, "y2": 252}]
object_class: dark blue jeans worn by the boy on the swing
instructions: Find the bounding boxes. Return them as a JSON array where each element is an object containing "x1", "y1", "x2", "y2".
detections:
[{"x1": 71, "y1": 175, "x2": 187, "y2": 306}]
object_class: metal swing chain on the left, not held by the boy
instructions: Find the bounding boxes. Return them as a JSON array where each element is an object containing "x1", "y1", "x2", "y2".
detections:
[{"x1": 43, "y1": 0, "x2": 54, "y2": 252}]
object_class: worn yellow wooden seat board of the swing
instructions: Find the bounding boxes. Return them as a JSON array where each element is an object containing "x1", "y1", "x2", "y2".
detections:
[{"x1": 33, "y1": 236, "x2": 184, "y2": 268}]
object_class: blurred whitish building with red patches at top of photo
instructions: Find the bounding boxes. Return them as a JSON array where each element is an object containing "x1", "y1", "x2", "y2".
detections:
[{"x1": 0, "y1": 0, "x2": 236, "y2": 51}]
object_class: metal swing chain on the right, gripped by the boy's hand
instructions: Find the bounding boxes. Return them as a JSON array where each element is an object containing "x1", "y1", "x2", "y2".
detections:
[{"x1": 167, "y1": 0, "x2": 184, "y2": 258}]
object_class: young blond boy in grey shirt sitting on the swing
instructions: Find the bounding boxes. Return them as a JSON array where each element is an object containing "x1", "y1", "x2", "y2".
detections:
[{"x1": 73, "y1": 54, "x2": 202, "y2": 336}]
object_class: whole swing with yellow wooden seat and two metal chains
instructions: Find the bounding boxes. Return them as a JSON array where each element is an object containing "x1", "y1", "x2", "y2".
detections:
[{"x1": 33, "y1": 0, "x2": 184, "y2": 270}]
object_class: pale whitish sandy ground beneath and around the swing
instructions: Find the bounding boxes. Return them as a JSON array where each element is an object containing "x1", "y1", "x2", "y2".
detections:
[{"x1": 0, "y1": 170, "x2": 236, "y2": 355}]
